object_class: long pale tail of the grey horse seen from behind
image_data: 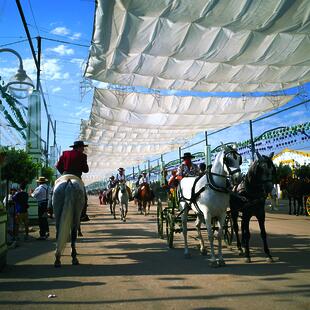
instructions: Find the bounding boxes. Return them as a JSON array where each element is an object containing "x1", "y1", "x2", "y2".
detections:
[{"x1": 57, "y1": 179, "x2": 74, "y2": 254}]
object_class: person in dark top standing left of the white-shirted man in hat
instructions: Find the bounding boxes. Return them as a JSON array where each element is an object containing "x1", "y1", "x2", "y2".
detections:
[{"x1": 12, "y1": 183, "x2": 29, "y2": 240}]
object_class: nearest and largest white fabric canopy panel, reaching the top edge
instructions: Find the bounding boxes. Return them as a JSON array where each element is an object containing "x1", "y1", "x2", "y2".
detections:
[{"x1": 85, "y1": 0, "x2": 310, "y2": 92}]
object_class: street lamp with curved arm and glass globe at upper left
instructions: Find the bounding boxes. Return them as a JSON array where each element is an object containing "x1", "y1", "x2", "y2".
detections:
[{"x1": 0, "y1": 48, "x2": 34, "y2": 99}]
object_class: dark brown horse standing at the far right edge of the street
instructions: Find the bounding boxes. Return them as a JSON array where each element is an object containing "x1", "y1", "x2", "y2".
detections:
[{"x1": 280, "y1": 176, "x2": 310, "y2": 215}]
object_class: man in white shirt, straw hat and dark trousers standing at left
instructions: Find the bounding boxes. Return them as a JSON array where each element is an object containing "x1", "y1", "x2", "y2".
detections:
[{"x1": 31, "y1": 177, "x2": 50, "y2": 240}]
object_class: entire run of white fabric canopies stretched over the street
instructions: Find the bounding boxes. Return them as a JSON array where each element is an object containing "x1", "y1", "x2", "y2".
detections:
[{"x1": 80, "y1": 0, "x2": 310, "y2": 183}]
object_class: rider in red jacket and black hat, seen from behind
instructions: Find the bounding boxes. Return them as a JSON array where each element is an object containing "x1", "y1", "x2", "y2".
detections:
[{"x1": 56, "y1": 141, "x2": 89, "y2": 222}]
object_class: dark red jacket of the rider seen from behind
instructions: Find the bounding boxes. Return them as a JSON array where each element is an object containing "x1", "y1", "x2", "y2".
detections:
[{"x1": 56, "y1": 149, "x2": 89, "y2": 178}]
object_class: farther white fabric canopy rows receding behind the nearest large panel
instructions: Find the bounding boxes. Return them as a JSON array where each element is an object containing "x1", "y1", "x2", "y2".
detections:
[{"x1": 80, "y1": 89, "x2": 291, "y2": 183}]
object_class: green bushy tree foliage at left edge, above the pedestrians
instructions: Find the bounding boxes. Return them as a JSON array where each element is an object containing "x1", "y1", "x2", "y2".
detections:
[{"x1": 1, "y1": 148, "x2": 40, "y2": 184}]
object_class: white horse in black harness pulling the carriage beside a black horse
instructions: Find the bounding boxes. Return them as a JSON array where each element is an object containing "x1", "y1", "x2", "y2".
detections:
[{"x1": 178, "y1": 146, "x2": 242, "y2": 267}]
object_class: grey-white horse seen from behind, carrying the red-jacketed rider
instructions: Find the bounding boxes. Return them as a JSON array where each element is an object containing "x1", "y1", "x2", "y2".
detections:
[{"x1": 52, "y1": 174, "x2": 85, "y2": 267}]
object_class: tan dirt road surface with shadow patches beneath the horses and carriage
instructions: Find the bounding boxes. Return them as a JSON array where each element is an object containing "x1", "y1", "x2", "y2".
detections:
[{"x1": 0, "y1": 198, "x2": 310, "y2": 310}]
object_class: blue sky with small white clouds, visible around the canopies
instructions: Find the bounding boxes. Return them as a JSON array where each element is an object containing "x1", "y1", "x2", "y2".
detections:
[{"x1": 0, "y1": 0, "x2": 310, "y2": 170}]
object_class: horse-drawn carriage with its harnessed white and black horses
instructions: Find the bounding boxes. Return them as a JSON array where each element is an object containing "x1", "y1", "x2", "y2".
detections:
[{"x1": 157, "y1": 147, "x2": 276, "y2": 267}]
